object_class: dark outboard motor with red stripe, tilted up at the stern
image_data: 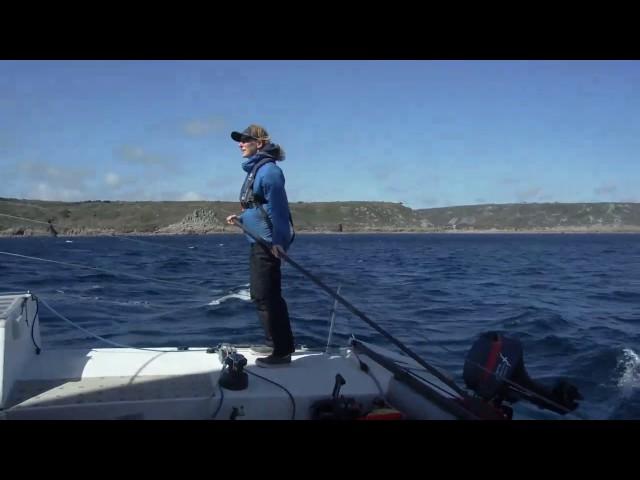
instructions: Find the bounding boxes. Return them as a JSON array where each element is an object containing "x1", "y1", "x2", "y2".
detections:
[{"x1": 463, "y1": 332, "x2": 582, "y2": 415}]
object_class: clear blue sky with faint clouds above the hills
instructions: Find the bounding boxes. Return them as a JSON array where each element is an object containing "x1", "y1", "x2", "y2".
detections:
[{"x1": 0, "y1": 60, "x2": 640, "y2": 208}]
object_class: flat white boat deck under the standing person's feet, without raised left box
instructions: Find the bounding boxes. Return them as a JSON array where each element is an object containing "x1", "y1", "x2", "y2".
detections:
[{"x1": 3, "y1": 348, "x2": 391, "y2": 419}]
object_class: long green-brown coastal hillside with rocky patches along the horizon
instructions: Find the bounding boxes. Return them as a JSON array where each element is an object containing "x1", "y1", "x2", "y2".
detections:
[{"x1": 0, "y1": 198, "x2": 640, "y2": 235}]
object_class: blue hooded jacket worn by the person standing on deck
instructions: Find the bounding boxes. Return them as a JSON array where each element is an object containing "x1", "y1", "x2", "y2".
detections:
[{"x1": 238, "y1": 144, "x2": 292, "y2": 250}]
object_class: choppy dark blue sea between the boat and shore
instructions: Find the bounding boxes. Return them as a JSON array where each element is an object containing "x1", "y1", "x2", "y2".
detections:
[{"x1": 5, "y1": 234, "x2": 640, "y2": 418}]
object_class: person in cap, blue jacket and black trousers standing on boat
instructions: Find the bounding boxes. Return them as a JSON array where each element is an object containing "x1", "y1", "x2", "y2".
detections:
[{"x1": 227, "y1": 125, "x2": 295, "y2": 367}]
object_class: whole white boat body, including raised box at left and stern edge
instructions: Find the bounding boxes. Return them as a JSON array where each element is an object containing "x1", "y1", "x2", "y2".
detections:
[{"x1": 0, "y1": 294, "x2": 496, "y2": 420}]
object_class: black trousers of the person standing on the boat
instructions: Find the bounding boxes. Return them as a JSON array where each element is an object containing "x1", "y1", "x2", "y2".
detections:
[{"x1": 249, "y1": 243, "x2": 295, "y2": 355}]
